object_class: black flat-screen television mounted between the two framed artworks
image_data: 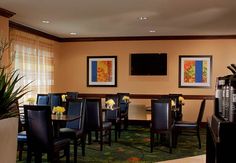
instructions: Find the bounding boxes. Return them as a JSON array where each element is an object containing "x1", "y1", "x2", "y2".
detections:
[{"x1": 130, "y1": 53, "x2": 167, "y2": 76}]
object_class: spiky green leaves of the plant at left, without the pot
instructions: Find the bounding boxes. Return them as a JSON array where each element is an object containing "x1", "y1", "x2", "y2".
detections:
[{"x1": 0, "y1": 37, "x2": 30, "y2": 119}]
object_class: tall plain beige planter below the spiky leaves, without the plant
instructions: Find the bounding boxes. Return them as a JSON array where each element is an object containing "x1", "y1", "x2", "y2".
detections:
[{"x1": 0, "y1": 118, "x2": 18, "y2": 163}]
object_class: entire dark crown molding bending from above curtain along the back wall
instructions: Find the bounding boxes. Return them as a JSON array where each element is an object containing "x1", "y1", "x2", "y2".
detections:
[{"x1": 9, "y1": 21, "x2": 236, "y2": 42}]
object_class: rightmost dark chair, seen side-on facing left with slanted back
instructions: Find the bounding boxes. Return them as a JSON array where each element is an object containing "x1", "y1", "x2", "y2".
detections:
[{"x1": 174, "y1": 99, "x2": 206, "y2": 149}]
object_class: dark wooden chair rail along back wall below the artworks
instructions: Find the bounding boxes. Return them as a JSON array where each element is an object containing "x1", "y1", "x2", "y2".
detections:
[{"x1": 79, "y1": 93, "x2": 215, "y2": 100}]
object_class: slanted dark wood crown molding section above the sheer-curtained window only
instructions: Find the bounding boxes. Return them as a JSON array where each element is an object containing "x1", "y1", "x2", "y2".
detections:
[{"x1": 9, "y1": 21, "x2": 61, "y2": 42}]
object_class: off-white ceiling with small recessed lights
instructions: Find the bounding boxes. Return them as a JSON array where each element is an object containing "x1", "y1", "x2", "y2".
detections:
[{"x1": 0, "y1": 0, "x2": 236, "y2": 38}]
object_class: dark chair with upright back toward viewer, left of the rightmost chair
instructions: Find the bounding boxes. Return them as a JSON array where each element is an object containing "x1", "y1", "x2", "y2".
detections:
[{"x1": 150, "y1": 98, "x2": 173, "y2": 153}]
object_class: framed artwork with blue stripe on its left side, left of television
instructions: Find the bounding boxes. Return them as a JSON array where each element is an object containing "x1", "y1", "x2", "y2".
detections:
[{"x1": 87, "y1": 56, "x2": 117, "y2": 87}]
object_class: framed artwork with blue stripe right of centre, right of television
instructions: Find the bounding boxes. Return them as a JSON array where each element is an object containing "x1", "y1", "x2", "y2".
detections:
[{"x1": 179, "y1": 55, "x2": 212, "y2": 88}]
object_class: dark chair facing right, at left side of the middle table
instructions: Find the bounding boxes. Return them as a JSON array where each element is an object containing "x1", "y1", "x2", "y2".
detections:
[{"x1": 85, "y1": 98, "x2": 112, "y2": 151}]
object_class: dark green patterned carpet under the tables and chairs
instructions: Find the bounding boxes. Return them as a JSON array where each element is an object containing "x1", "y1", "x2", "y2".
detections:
[{"x1": 18, "y1": 126, "x2": 206, "y2": 163}]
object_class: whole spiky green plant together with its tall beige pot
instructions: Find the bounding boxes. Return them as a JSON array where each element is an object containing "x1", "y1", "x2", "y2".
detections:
[{"x1": 0, "y1": 36, "x2": 28, "y2": 162}]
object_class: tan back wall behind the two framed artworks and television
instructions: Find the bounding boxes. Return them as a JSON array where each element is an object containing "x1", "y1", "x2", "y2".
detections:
[{"x1": 55, "y1": 40, "x2": 236, "y2": 121}]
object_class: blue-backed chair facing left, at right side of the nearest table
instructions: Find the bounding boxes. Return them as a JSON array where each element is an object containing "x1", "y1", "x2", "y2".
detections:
[{"x1": 60, "y1": 99, "x2": 86, "y2": 162}]
